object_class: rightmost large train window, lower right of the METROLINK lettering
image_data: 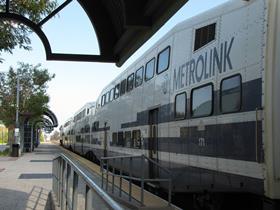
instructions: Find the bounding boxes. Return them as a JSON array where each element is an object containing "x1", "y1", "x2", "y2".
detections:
[{"x1": 220, "y1": 75, "x2": 241, "y2": 113}]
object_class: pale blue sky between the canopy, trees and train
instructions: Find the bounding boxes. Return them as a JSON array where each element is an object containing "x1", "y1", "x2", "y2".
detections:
[{"x1": 0, "y1": 0, "x2": 228, "y2": 130}]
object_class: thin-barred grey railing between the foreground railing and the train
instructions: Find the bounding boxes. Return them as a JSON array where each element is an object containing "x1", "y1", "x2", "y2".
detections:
[{"x1": 100, "y1": 155, "x2": 172, "y2": 206}]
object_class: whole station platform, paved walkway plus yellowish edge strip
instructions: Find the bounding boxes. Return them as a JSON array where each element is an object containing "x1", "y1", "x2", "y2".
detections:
[{"x1": 0, "y1": 143, "x2": 177, "y2": 210}]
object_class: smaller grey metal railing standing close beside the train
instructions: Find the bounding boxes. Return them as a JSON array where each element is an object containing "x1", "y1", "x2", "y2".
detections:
[{"x1": 100, "y1": 155, "x2": 172, "y2": 206}]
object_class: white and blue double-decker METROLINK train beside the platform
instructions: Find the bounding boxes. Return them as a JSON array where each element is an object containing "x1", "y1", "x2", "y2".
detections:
[{"x1": 62, "y1": 0, "x2": 280, "y2": 209}]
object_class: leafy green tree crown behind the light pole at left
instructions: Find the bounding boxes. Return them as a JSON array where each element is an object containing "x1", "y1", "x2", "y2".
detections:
[{"x1": 0, "y1": 63, "x2": 55, "y2": 128}]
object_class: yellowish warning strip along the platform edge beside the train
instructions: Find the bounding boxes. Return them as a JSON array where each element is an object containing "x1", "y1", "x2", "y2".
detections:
[{"x1": 62, "y1": 147, "x2": 175, "y2": 208}]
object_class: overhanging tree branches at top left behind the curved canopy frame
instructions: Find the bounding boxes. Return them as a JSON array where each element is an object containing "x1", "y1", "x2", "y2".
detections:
[{"x1": 0, "y1": 0, "x2": 57, "y2": 62}]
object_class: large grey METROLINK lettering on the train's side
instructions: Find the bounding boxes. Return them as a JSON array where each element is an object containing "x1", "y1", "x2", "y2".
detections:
[{"x1": 173, "y1": 37, "x2": 234, "y2": 90}]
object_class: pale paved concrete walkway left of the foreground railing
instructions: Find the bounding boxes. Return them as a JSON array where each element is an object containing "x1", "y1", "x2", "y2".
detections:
[{"x1": 0, "y1": 143, "x2": 60, "y2": 210}]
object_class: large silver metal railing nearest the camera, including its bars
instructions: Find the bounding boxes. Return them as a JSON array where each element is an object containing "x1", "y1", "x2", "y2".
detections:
[{"x1": 52, "y1": 154, "x2": 123, "y2": 210}]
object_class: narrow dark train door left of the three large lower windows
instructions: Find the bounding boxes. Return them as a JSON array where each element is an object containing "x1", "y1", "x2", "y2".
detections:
[{"x1": 148, "y1": 109, "x2": 158, "y2": 178}]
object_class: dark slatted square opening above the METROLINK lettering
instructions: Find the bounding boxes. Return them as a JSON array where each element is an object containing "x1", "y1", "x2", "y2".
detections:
[{"x1": 194, "y1": 23, "x2": 216, "y2": 51}]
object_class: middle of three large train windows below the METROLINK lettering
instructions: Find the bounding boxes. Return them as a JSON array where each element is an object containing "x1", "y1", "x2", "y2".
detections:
[{"x1": 191, "y1": 84, "x2": 213, "y2": 117}]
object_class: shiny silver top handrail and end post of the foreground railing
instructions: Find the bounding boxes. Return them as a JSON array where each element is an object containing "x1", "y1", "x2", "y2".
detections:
[{"x1": 53, "y1": 153, "x2": 123, "y2": 210}]
